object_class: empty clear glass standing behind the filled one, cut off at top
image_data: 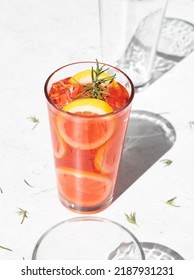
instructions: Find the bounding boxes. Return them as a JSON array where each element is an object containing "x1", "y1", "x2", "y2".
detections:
[{"x1": 99, "y1": 0, "x2": 168, "y2": 89}]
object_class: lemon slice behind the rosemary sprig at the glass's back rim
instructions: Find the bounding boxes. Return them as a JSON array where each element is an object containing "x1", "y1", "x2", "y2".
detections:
[{"x1": 69, "y1": 69, "x2": 111, "y2": 84}]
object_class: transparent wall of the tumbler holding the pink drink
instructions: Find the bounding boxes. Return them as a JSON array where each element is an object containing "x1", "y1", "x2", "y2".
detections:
[{"x1": 45, "y1": 62, "x2": 134, "y2": 213}]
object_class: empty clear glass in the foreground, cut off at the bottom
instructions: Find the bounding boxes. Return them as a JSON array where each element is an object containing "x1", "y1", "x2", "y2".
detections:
[{"x1": 32, "y1": 216, "x2": 145, "y2": 260}]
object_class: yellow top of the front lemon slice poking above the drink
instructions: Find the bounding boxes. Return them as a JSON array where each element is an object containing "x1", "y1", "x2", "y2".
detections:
[{"x1": 63, "y1": 98, "x2": 113, "y2": 115}]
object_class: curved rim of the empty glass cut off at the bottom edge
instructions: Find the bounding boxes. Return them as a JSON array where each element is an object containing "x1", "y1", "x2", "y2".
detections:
[{"x1": 32, "y1": 216, "x2": 145, "y2": 260}]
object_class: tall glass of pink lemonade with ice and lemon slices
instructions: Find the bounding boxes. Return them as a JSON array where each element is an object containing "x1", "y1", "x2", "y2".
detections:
[{"x1": 45, "y1": 63, "x2": 134, "y2": 213}]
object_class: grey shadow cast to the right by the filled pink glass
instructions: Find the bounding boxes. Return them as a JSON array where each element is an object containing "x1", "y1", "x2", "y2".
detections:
[{"x1": 113, "y1": 110, "x2": 176, "y2": 201}]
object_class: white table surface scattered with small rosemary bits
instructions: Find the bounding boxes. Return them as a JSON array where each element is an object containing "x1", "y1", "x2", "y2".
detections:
[{"x1": 0, "y1": 0, "x2": 194, "y2": 260}]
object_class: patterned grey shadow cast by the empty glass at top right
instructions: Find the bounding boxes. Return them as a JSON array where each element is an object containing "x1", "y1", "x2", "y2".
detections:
[{"x1": 118, "y1": 15, "x2": 194, "y2": 91}]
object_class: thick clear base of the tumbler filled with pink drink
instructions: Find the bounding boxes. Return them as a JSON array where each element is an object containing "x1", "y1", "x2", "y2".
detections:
[{"x1": 59, "y1": 194, "x2": 113, "y2": 214}]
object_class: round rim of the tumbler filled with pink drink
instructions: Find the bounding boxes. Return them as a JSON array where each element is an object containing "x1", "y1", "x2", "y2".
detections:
[{"x1": 44, "y1": 61, "x2": 135, "y2": 119}]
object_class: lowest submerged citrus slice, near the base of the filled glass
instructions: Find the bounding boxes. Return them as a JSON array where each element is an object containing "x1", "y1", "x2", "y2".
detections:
[{"x1": 56, "y1": 167, "x2": 113, "y2": 207}]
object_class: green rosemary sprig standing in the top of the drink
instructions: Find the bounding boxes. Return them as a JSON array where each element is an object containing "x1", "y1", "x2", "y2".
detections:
[{"x1": 73, "y1": 60, "x2": 116, "y2": 100}]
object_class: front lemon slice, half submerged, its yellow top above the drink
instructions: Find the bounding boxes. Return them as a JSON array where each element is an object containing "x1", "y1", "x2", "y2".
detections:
[{"x1": 57, "y1": 98, "x2": 115, "y2": 150}]
